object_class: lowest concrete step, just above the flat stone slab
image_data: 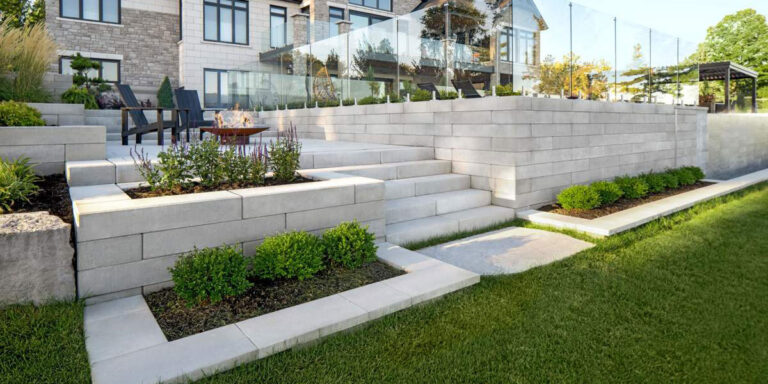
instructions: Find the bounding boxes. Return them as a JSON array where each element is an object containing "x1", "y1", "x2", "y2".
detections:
[{"x1": 387, "y1": 205, "x2": 515, "y2": 245}]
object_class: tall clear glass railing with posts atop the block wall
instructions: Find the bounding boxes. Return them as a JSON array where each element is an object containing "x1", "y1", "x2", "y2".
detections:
[{"x1": 229, "y1": 0, "x2": 699, "y2": 109}]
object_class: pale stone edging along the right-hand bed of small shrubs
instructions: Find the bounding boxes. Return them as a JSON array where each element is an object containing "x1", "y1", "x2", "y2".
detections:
[{"x1": 518, "y1": 169, "x2": 768, "y2": 236}]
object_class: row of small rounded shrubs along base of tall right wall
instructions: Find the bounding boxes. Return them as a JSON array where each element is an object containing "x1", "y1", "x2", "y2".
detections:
[{"x1": 557, "y1": 167, "x2": 704, "y2": 210}]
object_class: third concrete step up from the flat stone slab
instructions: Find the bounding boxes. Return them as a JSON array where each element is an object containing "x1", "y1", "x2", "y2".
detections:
[{"x1": 385, "y1": 173, "x2": 470, "y2": 200}]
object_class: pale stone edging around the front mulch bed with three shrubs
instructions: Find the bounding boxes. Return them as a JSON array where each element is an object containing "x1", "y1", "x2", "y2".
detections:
[{"x1": 85, "y1": 243, "x2": 480, "y2": 384}]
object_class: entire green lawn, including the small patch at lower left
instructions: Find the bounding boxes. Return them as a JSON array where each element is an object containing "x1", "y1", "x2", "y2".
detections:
[{"x1": 0, "y1": 184, "x2": 768, "y2": 384}]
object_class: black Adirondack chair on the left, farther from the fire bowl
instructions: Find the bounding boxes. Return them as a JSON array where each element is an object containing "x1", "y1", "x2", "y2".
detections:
[{"x1": 117, "y1": 84, "x2": 187, "y2": 145}]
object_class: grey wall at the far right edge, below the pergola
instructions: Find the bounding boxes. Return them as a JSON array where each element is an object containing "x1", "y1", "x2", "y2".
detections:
[{"x1": 707, "y1": 114, "x2": 768, "y2": 179}]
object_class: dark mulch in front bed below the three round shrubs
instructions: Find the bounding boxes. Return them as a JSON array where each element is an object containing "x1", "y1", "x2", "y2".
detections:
[{"x1": 145, "y1": 261, "x2": 403, "y2": 341}]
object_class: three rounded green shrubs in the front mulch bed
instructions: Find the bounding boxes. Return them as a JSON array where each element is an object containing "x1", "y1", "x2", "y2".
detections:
[{"x1": 170, "y1": 221, "x2": 377, "y2": 305}]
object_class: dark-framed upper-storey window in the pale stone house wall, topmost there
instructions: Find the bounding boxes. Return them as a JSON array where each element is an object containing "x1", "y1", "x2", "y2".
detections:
[{"x1": 203, "y1": 0, "x2": 248, "y2": 45}]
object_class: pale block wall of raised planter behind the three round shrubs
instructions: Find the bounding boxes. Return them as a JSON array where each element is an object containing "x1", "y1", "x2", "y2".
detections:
[{"x1": 70, "y1": 174, "x2": 386, "y2": 301}]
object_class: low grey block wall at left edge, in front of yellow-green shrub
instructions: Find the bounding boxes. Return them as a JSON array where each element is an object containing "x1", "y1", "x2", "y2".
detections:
[{"x1": 0, "y1": 126, "x2": 106, "y2": 175}]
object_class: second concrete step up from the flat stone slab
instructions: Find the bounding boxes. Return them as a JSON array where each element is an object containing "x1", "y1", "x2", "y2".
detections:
[{"x1": 387, "y1": 189, "x2": 491, "y2": 224}]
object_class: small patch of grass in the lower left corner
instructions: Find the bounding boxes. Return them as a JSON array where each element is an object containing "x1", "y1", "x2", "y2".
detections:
[{"x1": 0, "y1": 302, "x2": 91, "y2": 384}]
